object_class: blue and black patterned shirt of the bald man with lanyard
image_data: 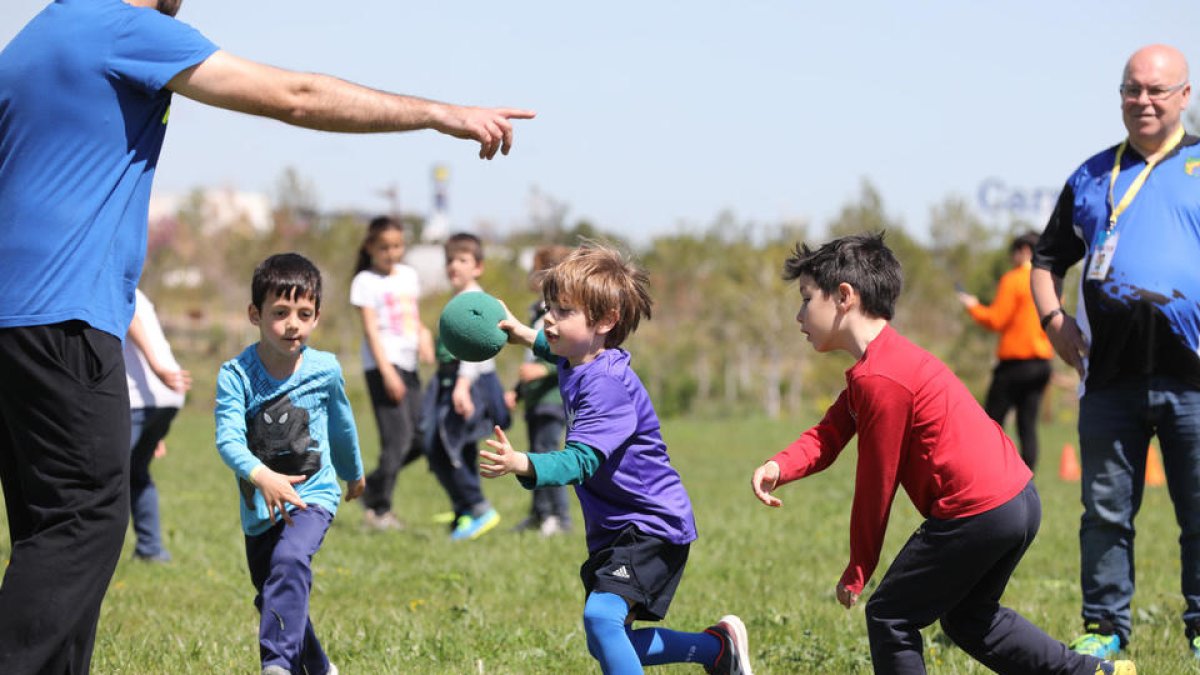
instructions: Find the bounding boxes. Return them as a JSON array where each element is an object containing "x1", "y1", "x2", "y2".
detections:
[{"x1": 1033, "y1": 136, "x2": 1200, "y2": 390}]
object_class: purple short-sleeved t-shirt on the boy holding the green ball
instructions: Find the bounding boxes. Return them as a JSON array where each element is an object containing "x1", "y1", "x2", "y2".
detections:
[{"x1": 558, "y1": 350, "x2": 696, "y2": 552}]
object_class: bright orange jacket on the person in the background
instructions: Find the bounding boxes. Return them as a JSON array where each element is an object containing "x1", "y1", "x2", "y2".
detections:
[{"x1": 967, "y1": 263, "x2": 1054, "y2": 360}]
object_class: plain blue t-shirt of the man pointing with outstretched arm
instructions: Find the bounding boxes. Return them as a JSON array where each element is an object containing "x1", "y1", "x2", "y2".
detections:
[{"x1": 0, "y1": 0, "x2": 217, "y2": 338}]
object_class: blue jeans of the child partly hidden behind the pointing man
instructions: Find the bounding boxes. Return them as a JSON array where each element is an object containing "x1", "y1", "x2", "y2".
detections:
[{"x1": 130, "y1": 408, "x2": 179, "y2": 558}]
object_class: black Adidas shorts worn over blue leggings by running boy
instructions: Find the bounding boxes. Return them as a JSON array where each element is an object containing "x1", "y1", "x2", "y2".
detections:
[{"x1": 580, "y1": 525, "x2": 691, "y2": 621}]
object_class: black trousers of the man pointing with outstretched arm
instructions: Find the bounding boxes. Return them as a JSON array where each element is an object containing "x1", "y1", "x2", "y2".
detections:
[{"x1": 0, "y1": 321, "x2": 130, "y2": 675}]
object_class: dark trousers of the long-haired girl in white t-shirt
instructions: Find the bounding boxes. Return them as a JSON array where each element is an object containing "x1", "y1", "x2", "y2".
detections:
[{"x1": 362, "y1": 364, "x2": 422, "y2": 514}]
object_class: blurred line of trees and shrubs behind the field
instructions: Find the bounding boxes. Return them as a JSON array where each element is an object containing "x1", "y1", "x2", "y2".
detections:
[{"x1": 142, "y1": 173, "x2": 1075, "y2": 417}]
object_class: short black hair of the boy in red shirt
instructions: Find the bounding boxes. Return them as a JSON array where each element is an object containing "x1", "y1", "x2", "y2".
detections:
[{"x1": 784, "y1": 232, "x2": 904, "y2": 321}]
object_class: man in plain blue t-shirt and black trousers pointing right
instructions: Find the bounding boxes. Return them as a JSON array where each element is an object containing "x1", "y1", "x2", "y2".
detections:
[{"x1": 0, "y1": 0, "x2": 534, "y2": 673}]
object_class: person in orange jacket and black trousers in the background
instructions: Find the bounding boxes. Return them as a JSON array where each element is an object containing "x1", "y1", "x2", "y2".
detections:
[{"x1": 958, "y1": 232, "x2": 1054, "y2": 470}]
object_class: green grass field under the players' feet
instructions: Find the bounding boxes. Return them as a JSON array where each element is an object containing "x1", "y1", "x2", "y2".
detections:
[{"x1": 0, "y1": 405, "x2": 1195, "y2": 675}]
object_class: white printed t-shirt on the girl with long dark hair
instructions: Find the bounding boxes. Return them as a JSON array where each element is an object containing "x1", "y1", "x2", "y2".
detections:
[{"x1": 350, "y1": 263, "x2": 421, "y2": 370}]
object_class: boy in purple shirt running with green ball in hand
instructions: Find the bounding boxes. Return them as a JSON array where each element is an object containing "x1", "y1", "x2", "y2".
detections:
[{"x1": 479, "y1": 245, "x2": 750, "y2": 675}]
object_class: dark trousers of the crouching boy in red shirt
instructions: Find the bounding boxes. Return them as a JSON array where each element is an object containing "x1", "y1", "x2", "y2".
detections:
[{"x1": 866, "y1": 482, "x2": 1099, "y2": 675}]
